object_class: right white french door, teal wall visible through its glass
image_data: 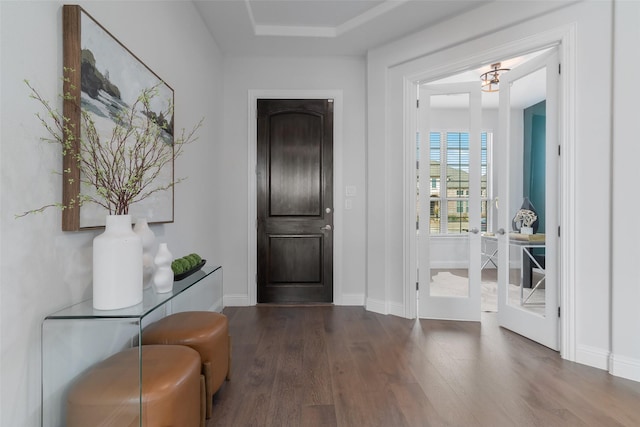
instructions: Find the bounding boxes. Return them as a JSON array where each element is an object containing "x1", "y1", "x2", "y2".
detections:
[{"x1": 496, "y1": 48, "x2": 559, "y2": 350}]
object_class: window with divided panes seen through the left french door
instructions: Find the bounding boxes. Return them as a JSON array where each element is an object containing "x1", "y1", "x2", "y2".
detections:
[{"x1": 422, "y1": 131, "x2": 492, "y2": 234}]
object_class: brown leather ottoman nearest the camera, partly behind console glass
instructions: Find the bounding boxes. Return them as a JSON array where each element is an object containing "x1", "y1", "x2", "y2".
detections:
[{"x1": 66, "y1": 345, "x2": 201, "y2": 427}]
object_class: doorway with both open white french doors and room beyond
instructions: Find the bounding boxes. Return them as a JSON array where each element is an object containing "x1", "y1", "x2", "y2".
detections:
[{"x1": 415, "y1": 47, "x2": 560, "y2": 348}]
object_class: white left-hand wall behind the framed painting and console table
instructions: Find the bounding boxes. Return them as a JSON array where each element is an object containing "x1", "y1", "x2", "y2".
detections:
[{"x1": 0, "y1": 1, "x2": 223, "y2": 427}]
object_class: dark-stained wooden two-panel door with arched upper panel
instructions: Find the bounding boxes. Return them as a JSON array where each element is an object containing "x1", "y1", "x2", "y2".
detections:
[{"x1": 256, "y1": 99, "x2": 333, "y2": 303}]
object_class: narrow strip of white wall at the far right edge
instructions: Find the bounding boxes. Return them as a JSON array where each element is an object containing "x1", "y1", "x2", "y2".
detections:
[{"x1": 605, "y1": 1, "x2": 640, "y2": 381}]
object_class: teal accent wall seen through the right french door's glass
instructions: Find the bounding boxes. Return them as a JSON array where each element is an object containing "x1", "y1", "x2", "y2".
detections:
[{"x1": 523, "y1": 101, "x2": 547, "y2": 233}]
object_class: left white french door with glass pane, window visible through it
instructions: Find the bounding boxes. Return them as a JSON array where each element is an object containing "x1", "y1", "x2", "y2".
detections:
[{"x1": 417, "y1": 82, "x2": 481, "y2": 321}]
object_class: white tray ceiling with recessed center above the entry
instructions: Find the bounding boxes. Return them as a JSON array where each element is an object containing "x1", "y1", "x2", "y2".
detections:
[{"x1": 193, "y1": 0, "x2": 493, "y2": 56}]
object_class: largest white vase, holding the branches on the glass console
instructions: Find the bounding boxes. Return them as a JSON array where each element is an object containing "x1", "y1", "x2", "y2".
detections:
[{"x1": 93, "y1": 215, "x2": 142, "y2": 310}]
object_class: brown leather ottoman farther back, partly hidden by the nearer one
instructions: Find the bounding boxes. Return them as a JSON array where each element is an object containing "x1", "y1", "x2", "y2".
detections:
[{"x1": 142, "y1": 311, "x2": 231, "y2": 418}]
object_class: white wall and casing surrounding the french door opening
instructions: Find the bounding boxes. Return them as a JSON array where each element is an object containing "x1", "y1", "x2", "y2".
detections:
[{"x1": 367, "y1": 1, "x2": 640, "y2": 382}]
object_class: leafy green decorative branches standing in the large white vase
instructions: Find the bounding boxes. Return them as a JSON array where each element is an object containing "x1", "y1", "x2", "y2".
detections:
[{"x1": 16, "y1": 68, "x2": 204, "y2": 221}]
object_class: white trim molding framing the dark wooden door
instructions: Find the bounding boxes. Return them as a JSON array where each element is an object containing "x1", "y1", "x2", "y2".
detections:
[{"x1": 246, "y1": 89, "x2": 344, "y2": 305}]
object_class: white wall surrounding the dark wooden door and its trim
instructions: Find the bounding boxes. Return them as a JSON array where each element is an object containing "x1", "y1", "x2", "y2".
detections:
[{"x1": 217, "y1": 57, "x2": 366, "y2": 305}]
